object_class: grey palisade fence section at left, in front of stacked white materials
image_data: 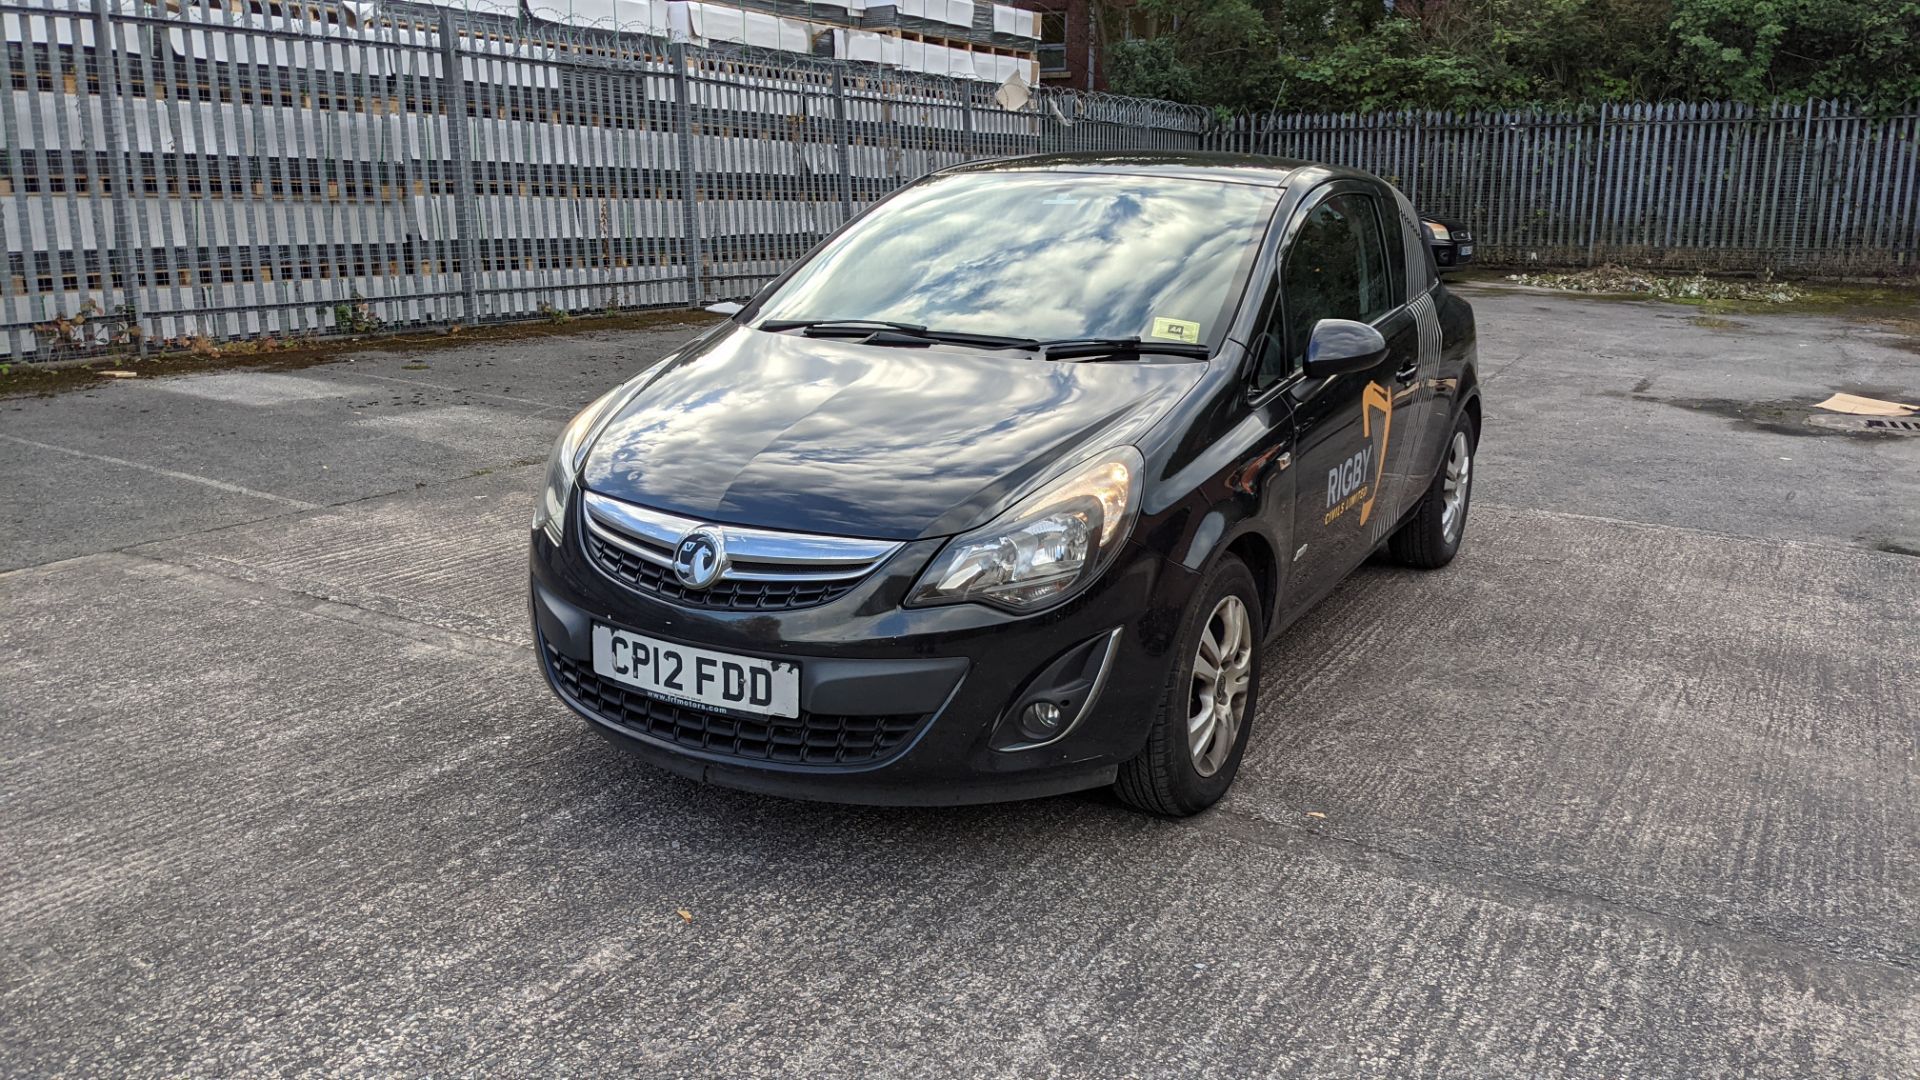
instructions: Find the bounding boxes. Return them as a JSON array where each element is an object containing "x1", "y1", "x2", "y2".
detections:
[{"x1": 0, "y1": 0, "x2": 1204, "y2": 359}]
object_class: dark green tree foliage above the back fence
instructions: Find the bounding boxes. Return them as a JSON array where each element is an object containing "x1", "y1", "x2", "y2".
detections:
[{"x1": 1104, "y1": 0, "x2": 1920, "y2": 111}]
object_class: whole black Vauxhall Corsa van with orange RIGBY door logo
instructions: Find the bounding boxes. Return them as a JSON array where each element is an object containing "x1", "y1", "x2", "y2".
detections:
[{"x1": 532, "y1": 154, "x2": 1480, "y2": 815}]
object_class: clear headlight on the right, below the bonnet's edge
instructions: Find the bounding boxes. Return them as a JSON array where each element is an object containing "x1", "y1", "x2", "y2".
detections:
[{"x1": 906, "y1": 446, "x2": 1146, "y2": 611}]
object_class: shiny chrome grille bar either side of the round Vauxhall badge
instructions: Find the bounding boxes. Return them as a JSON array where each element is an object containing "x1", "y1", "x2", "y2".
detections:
[{"x1": 580, "y1": 492, "x2": 904, "y2": 584}]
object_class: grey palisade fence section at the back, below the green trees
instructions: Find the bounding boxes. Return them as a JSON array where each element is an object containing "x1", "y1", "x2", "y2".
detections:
[{"x1": 1210, "y1": 102, "x2": 1920, "y2": 275}]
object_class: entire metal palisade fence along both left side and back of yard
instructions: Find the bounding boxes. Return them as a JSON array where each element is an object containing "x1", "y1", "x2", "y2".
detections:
[{"x1": 0, "y1": 0, "x2": 1920, "y2": 359}]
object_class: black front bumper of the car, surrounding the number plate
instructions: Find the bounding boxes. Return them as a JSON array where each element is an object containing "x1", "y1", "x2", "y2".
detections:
[{"x1": 530, "y1": 499, "x2": 1194, "y2": 805}]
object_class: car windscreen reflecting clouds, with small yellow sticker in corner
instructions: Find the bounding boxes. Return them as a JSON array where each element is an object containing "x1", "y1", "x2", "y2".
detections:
[{"x1": 758, "y1": 173, "x2": 1281, "y2": 346}]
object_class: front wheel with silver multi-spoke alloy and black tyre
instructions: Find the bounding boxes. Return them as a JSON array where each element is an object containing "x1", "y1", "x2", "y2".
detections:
[{"x1": 1114, "y1": 555, "x2": 1261, "y2": 817}]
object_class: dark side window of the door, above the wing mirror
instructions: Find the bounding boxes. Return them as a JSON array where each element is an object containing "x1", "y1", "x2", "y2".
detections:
[{"x1": 1281, "y1": 192, "x2": 1394, "y2": 371}]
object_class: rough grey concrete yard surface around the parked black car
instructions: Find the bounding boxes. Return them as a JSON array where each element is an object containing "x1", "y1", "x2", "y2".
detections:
[{"x1": 0, "y1": 288, "x2": 1920, "y2": 1078}]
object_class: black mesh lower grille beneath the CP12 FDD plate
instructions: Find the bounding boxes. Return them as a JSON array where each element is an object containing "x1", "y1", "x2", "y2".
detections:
[{"x1": 540, "y1": 640, "x2": 924, "y2": 765}]
